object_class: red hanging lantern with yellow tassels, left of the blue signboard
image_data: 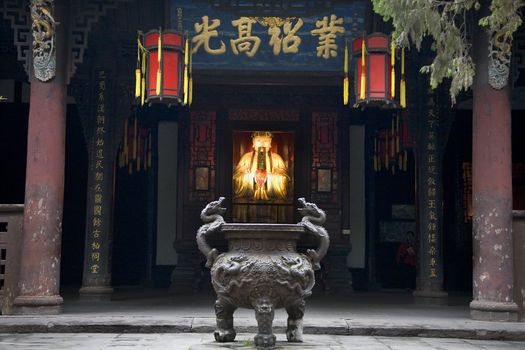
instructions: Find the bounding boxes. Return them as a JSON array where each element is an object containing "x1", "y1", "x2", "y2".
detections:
[{"x1": 135, "y1": 30, "x2": 189, "y2": 105}]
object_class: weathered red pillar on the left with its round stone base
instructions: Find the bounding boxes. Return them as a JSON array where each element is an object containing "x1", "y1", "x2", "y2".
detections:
[{"x1": 14, "y1": 1, "x2": 67, "y2": 314}]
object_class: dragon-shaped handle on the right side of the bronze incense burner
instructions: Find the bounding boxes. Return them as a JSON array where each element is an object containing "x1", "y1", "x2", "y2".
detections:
[{"x1": 297, "y1": 198, "x2": 330, "y2": 270}]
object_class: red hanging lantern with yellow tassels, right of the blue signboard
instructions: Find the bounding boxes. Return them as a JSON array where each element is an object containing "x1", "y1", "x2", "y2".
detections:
[{"x1": 352, "y1": 33, "x2": 404, "y2": 107}]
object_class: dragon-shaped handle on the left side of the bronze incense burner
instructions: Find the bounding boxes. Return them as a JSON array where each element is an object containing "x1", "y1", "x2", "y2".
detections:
[{"x1": 197, "y1": 197, "x2": 226, "y2": 267}]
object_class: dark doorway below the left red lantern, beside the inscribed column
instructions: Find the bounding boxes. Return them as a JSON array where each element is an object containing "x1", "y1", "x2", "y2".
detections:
[{"x1": 112, "y1": 113, "x2": 157, "y2": 285}]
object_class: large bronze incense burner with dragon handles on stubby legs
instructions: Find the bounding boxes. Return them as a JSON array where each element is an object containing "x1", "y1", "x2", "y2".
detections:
[{"x1": 197, "y1": 197, "x2": 329, "y2": 348}]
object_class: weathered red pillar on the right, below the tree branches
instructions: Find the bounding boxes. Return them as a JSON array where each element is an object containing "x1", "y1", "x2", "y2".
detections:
[{"x1": 470, "y1": 2, "x2": 518, "y2": 321}]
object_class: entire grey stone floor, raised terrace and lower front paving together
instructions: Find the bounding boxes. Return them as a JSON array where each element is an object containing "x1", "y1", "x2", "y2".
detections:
[{"x1": 4, "y1": 289, "x2": 525, "y2": 350}]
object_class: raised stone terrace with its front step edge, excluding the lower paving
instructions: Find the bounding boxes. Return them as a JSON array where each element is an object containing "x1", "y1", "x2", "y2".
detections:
[{"x1": 4, "y1": 289, "x2": 525, "y2": 340}]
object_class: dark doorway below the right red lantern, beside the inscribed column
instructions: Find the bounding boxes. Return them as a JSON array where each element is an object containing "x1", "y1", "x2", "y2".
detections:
[{"x1": 366, "y1": 109, "x2": 417, "y2": 289}]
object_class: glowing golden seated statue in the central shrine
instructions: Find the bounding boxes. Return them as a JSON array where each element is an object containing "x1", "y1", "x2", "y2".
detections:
[{"x1": 233, "y1": 131, "x2": 290, "y2": 201}]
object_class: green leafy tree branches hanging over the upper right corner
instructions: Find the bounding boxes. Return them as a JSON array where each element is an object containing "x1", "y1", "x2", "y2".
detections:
[{"x1": 372, "y1": 0, "x2": 525, "y2": 103}]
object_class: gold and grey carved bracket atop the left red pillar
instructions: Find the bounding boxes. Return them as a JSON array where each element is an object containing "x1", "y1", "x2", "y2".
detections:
[{"x1": 31, "y1": 0, "x2": 56, "y2": 82}]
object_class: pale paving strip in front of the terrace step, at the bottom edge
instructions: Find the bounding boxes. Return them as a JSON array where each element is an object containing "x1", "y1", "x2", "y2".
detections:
[{"x1": 0, "y1": 333, "x2": 525, "y2": 350}]
